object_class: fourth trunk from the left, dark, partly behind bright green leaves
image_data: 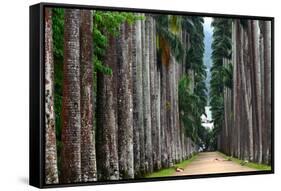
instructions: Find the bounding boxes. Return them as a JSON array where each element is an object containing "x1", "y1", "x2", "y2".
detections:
[{"x1": 96, "y1": 35, "x2": 119, "y2": 180}]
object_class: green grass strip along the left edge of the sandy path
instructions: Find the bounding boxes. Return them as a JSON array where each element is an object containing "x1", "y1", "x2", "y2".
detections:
[{"x1": 145, "y1": 154, "x2": 197, "y2": 178}]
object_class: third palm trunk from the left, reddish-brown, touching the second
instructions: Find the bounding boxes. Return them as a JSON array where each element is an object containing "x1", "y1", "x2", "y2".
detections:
[{"x1": 80, "y1": 10, "x2": 97, "y2": 182}]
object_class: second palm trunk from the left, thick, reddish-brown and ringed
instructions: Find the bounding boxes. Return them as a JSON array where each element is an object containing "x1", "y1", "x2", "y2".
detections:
[{"x1": 61, "y1": 9, "x2": 81, "y2": 183}]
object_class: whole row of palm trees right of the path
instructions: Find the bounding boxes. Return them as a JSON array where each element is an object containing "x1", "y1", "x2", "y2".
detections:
[{"x1": 211, "y1": 18, "x2": 272, "y2": 165}]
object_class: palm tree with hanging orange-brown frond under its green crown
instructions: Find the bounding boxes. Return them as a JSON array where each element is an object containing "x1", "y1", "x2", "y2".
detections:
[{"x1": 154, "y1": 15, "x2": 186, "y2": 166}]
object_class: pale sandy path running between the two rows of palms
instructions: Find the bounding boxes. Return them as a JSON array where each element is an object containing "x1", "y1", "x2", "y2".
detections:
[{"x1": 174, "y1": 152, "x2": 256, "y2": 176}]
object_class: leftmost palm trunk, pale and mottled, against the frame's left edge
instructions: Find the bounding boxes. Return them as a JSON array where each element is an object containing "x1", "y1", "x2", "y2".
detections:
[{"x1": 45, "y1": 8, "x2": 59, "y2": 184}]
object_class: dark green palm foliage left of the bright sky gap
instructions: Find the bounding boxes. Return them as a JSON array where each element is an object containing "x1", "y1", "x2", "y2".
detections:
[{"x1": 179, "y1": 17, "x2": 207, "y2": 146}]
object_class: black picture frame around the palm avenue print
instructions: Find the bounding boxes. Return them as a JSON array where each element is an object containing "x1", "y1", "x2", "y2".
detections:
[{"x1": 29, "y1": 3, "x2": 275, "y2": 188}]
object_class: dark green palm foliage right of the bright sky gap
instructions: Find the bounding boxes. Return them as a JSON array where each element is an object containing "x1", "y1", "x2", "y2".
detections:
[{"x1": 210, "y1": 18, "x2": 233, "y2": 145}]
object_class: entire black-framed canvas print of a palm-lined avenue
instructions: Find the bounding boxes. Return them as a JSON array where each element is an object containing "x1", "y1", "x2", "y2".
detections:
[{"x1": 29, "y1": 3, "x2": 274, "y2": 188}]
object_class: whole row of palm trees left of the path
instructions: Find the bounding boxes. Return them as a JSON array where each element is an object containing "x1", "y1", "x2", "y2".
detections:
[{"x1": 45, "y1": 9, "x2": 206, "y2": 184}]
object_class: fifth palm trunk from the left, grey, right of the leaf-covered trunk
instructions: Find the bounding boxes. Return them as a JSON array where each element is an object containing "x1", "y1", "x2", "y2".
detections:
[{"x1": 117, "y1": 23, "x2": 134, "y2": 179}]
